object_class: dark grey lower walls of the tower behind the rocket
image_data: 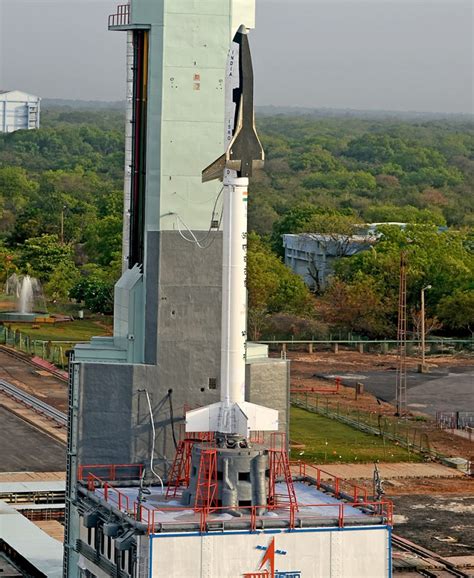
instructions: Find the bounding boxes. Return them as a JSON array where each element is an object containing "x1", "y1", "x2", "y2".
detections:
[{"x1": 74, "y1": 231, "x2": 288, "y2": 474}]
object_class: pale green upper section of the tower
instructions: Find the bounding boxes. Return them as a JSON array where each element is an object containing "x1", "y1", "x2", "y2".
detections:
[{"x1": 135, "y1": 0, "x2": 255, "y2": 236}]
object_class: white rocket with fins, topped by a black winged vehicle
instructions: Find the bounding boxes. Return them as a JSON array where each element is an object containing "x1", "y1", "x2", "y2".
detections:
[{"x1": 186, "y1": 26, "x2": 278, "y2": 438}]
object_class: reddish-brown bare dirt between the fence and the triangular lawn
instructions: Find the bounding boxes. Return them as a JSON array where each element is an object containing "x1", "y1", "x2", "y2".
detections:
[{"x1": 288, "y1": 351, "x2": 474, "y2": 459}]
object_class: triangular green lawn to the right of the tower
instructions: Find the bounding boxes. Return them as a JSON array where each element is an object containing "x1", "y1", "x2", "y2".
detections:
[{"x1": 290, "y1": 407, "x2": 421, "y2": 464}]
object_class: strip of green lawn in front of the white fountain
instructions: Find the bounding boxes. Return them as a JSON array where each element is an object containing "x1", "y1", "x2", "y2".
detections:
[{"x1": 8, "y1": 317, "x2": 112, "y2": 343}]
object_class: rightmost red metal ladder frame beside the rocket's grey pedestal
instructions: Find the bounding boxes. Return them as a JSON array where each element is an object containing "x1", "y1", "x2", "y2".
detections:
[{"x1": 268, "y1": 432, "x2": 298, "y2": 512}]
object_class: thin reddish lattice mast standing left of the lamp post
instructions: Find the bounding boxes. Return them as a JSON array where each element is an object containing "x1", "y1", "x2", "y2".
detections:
[{"x1": 395, "y1": 251, "x2": 407, "y2": 417}]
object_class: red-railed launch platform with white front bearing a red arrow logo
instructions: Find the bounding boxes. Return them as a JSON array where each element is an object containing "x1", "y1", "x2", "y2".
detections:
[{"x1": 70, "y1": 478, "x2": 392, "y2": 578}]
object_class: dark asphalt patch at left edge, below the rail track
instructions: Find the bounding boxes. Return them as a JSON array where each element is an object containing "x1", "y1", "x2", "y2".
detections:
[{"x1": 0, "y1": 406, "x2": 66, "y2": 472}]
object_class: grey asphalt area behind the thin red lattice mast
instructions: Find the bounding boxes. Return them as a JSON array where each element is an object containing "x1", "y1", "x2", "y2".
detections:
[{"x1": 322, "y1": 366, "x2": 474, "y2": 415}]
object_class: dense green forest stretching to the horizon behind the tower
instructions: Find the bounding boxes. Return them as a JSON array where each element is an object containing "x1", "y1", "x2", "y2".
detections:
[{"x1": 0, "y1": 106, "x2": 474, "y2": 338}]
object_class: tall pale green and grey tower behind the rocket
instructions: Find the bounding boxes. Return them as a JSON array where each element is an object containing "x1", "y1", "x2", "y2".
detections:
[{"x1": 65, "y1": 0, "x2": 288, "y2": 576}]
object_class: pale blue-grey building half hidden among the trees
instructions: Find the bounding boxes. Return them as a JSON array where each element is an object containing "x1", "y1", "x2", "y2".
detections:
[{"x1": 283, "y1": 230, "x2": 378, "y2": 291}]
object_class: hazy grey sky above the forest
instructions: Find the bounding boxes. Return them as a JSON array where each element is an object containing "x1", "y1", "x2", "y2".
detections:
[{"x1": 0, "y1": 0, "x2": 474, "y2": 113}]
